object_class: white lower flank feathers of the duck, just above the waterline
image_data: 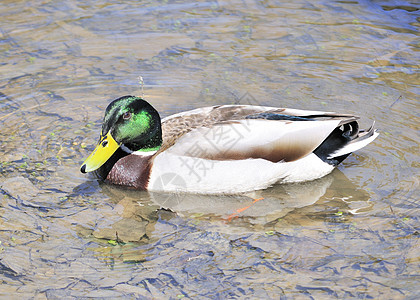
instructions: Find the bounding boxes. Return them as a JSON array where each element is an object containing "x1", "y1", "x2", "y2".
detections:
[{"x1": 148, "y1": 152, "x2": 334, "y2": 194}]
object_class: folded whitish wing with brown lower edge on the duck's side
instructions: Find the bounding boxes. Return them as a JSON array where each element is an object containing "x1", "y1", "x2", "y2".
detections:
[{"x1": 167, "y1": 119, "x2": 340, "y2": 162}]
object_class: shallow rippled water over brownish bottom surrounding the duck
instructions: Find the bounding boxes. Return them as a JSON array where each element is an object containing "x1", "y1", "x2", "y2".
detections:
[{"x1": 0, "y1": 0, "x2": 420, "y2": 299}]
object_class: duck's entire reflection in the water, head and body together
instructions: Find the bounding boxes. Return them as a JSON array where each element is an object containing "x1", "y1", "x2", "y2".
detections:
[{"x1": 88, "y1": 170, "x2": 371, "y2": 261}]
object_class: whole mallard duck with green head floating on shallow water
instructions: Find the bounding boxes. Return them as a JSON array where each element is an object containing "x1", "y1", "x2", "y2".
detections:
[{"x1": 80, "y1": 96, "x2": 378, "y2": 194}]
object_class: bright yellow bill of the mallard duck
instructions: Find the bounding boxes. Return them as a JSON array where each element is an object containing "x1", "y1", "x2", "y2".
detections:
[{"x1": 80, "y1": 132, "x2": 121, "y2": 173}]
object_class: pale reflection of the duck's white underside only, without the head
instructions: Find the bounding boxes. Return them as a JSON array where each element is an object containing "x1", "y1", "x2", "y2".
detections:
[{"x1": 150, "y1": 172, "x2": 333, "y2": 221}]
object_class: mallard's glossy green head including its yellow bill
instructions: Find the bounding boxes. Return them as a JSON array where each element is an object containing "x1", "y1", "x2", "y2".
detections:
[{"x1": 80, "y1": 96, "x2": 162, "y2": 173}]
